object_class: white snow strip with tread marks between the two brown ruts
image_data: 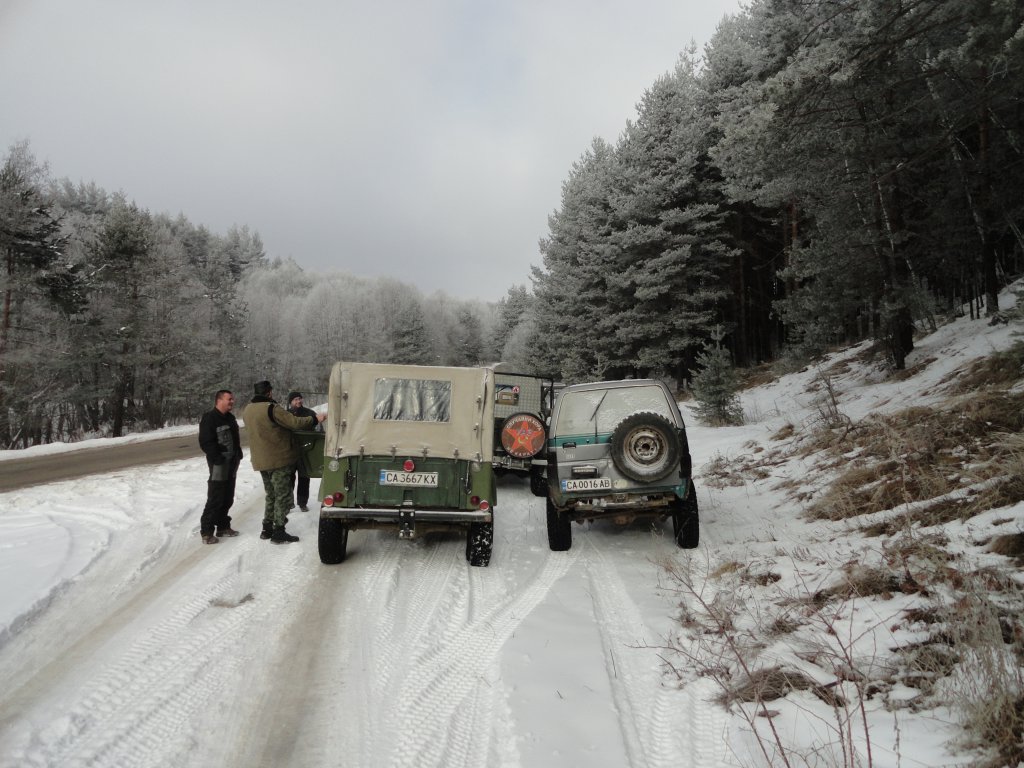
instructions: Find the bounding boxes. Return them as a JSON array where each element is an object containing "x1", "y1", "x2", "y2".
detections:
[{"x1": 2, "y1": 541, "x2": 301, "y2": 768}]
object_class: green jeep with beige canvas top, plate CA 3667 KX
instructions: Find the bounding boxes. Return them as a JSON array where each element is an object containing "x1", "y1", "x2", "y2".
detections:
[{"x1": 303, "y1": 362, "x2": 496, "y2": 566}]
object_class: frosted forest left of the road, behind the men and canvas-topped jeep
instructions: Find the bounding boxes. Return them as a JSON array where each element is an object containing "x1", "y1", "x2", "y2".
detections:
[{"x1": 0, "y1": 142, "x2": 512, "y2": 447}]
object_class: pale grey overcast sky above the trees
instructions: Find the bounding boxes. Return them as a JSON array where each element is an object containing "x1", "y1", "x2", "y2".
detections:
[{"x1": 0, "y1": 0, "x2": 739, "y2": 300}]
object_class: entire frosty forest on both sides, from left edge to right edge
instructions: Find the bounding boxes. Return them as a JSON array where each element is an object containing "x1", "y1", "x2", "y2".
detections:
[{"x1": 0, "y1": 0, "x2": 1024, "y2": 446}]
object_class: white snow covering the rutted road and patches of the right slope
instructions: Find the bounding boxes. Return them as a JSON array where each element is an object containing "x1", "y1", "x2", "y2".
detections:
[{"x1": 0, "y1": 299, "x2": 1024, "y2": 768}]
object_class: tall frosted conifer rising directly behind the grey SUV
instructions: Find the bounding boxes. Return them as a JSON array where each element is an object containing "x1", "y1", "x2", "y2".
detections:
[{"x1": 610, "y1": 51, "x2": 734, "y2": 379}]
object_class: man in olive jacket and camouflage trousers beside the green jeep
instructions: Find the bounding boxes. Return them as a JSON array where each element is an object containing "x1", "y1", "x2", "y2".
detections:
[{"x1": 242, "y1": 381, "x2": 327, "y2": 544}]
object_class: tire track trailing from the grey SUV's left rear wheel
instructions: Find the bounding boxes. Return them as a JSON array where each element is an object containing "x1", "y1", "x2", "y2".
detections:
[{"x1": 583, "y1": 539, "x2": 725, "y2": 768}]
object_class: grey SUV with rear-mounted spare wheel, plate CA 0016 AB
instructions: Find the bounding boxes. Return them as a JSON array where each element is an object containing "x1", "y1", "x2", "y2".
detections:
[{"x1": 547, "y1": 379, "x2": 699, "y2": 551}]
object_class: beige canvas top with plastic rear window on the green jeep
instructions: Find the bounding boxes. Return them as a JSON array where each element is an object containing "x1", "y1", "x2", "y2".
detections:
[{"x1": 324, "y1": 362, "x2": 495, "y2": 462}]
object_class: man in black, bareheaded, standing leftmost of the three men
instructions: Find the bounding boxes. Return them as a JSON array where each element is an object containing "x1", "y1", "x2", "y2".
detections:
[{"x1": 199, "y1": 389, "x2": 242, "y2": 544}]
